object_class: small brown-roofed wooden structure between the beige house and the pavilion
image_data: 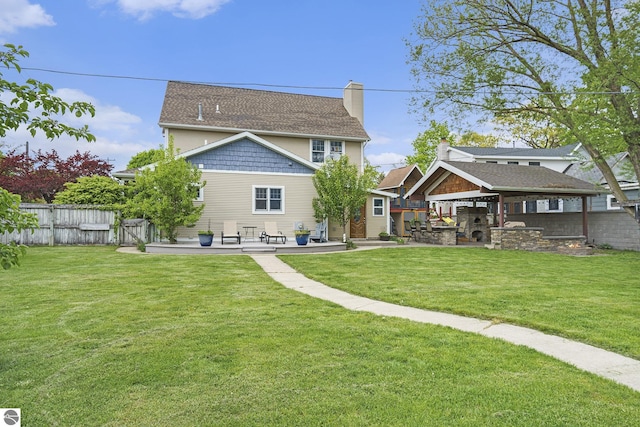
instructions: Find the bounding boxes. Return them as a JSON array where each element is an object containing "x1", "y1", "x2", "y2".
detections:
[{"x1": 378, "y1": 165, "x2": 428, "y2": 236}]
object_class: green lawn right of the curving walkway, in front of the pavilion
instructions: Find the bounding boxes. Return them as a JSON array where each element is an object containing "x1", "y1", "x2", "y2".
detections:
[{"x1": 280, "y1": 247, "x2": 640, "y2": 359}]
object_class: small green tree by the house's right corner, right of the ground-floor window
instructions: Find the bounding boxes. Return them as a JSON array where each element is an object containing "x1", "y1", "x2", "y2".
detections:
[{"x1": 312, "y1": 156, "x2": 376, "y2": 240}]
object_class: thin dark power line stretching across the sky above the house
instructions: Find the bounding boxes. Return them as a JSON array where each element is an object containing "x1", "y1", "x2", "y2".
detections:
[{"x1": 22, "y1": 67, "x2": 640, "y2": 95}]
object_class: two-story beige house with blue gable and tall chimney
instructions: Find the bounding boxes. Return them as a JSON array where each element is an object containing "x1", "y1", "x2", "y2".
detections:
[{"x1": 115, "y1": 81, "x2": 396, "y2": 240}]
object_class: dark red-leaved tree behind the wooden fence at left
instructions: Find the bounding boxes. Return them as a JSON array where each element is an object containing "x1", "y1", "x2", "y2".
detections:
[{"x1": 0, "y1": 150, "x2": 113, "y2": 203}]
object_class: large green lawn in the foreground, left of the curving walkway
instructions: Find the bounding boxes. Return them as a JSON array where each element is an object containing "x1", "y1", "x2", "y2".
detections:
[{"x1": 0, "y1": 247, "x2": 640, "y2": 426}]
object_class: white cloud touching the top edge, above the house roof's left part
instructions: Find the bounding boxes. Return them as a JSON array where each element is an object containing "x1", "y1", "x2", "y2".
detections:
[{"x1": 109, "y1": 0, "x2": 231, "y2": 20}]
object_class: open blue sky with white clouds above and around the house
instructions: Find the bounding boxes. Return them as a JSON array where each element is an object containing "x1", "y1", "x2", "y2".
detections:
[{"x1": 0, "y1": 0, "x2": 436, "y2": 172}]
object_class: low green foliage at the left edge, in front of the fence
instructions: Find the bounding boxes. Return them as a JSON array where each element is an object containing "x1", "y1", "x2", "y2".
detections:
[{"x1": 0, "y1": 188, "x2": 38, "y2": 270}]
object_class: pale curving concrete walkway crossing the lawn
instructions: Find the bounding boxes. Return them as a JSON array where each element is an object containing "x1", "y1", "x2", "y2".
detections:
[{"x1": 252, "y1": 254, "x2": 640, "y2": 391}]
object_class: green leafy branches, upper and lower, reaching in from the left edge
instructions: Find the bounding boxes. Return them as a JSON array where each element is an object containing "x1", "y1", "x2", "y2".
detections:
[{"x1": 0, "y1": 44, "x2": 95, "y2": 268}]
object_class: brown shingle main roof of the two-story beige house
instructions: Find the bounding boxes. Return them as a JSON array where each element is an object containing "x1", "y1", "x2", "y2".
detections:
[{"x1": 160, "y1": 81, "x2": 369, "y2": 140}]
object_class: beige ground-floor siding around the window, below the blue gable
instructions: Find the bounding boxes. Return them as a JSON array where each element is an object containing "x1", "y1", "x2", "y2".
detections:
[{"x1": 179, "y1": 171, "x2": 316, "y2": 240}]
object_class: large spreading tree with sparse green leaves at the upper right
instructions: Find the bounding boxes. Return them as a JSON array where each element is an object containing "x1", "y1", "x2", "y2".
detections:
[{"x1": 408, "y1": 0, "x2": 640, "y2": 217}]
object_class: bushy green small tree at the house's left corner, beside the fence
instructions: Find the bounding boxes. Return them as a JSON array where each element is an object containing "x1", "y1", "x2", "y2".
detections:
[{"x1": 128, "y1": 137, "x2": 205, "y2": 243}]
